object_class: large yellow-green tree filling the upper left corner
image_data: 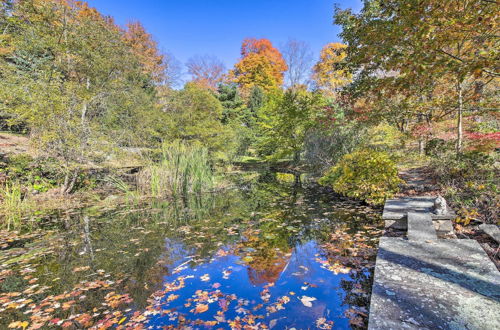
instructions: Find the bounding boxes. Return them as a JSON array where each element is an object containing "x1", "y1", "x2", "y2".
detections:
[{"x1": 0, "y1": 0, "x2": 160, "y2": 193}]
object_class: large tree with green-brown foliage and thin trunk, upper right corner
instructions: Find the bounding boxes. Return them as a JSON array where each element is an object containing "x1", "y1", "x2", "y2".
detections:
[{"x1": 335, "y1": 0, "x2": 500, "y2": 153}]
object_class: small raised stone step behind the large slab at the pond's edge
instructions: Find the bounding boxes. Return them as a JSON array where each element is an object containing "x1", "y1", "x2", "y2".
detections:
[{"x1": 382, "y1": 196, "x2": 456, "y2": 230}]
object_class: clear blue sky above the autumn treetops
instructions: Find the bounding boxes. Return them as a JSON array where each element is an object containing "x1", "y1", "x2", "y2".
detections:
[{"x1": 88, "y1": 0, "x2": 361, "y2": 68}]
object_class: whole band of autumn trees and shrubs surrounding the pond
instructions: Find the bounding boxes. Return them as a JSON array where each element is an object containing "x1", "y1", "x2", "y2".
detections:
[{"x1": 0, "y1": 0, "x2": 500, "y2": 224}]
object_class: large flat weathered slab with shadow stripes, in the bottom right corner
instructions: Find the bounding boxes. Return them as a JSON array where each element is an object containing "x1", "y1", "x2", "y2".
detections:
[{"x1": 368, "y1": 237, "x2": 500, "y2": 330}]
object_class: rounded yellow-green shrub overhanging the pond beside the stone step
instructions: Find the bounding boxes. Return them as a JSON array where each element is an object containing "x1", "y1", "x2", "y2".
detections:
[{"x1": 319, "y1": 150, "x2": 402, "y2": 205}]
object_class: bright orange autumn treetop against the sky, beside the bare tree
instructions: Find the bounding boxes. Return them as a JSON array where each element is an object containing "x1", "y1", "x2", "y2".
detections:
[{"x1": 230, "y1": 38, "x2": 287, "y2": 93}]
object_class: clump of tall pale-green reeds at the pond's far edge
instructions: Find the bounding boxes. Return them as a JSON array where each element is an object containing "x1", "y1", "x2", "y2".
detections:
[{"x1": 138, "y1": 141, "x2": 214, "y2": 198}]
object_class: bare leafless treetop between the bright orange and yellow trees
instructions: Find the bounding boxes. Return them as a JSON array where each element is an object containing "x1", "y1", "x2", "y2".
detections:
[{"x1": 281, "y1": 39, "x2": 313, "y2": 88}]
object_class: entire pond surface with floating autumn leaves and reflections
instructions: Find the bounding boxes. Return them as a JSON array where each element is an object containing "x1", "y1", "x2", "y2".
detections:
[{"x1": 0, "y1": 174, "x2": 381, "y2": 329}]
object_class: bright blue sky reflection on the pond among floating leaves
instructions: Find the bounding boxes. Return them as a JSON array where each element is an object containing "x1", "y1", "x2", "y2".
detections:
[{"x1": 148, "y1": 241, "x2": 356, "y2": 329}]
